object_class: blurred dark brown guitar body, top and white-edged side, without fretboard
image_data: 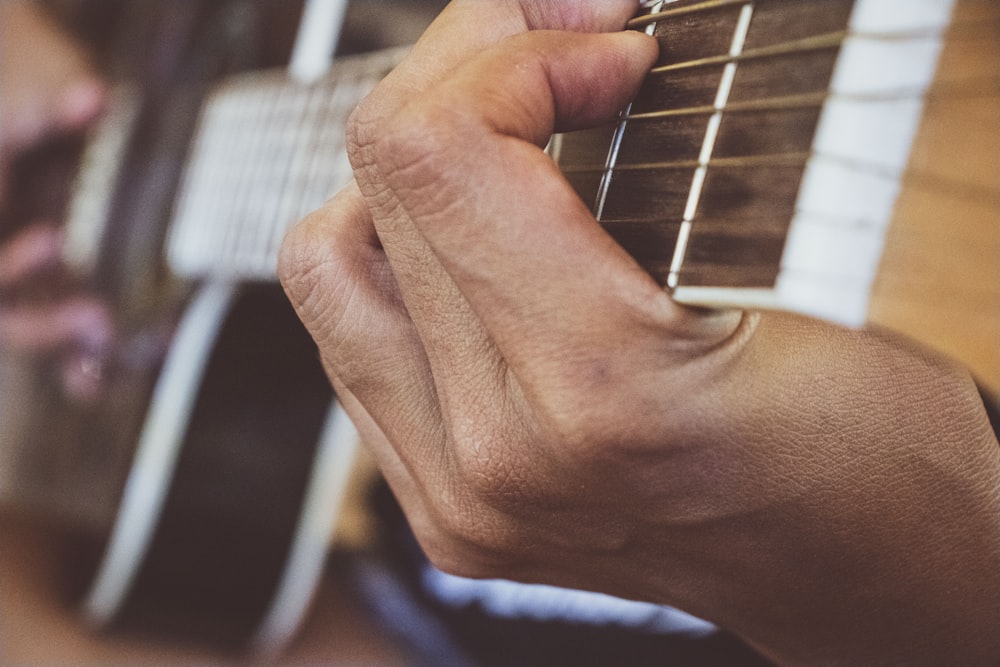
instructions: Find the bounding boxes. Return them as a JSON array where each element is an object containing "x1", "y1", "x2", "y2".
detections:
[{"x1": 3, "y1": 0, "x2": 353, "y2": 651}]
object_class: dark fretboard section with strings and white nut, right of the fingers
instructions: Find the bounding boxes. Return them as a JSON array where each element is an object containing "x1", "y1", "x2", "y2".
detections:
[{"x1": 555, "y1": 0, "x2": 952, "y2": 325}]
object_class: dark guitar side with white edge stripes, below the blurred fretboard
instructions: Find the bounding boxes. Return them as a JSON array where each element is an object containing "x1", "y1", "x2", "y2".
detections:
[{"x1": 74, "y1": 285, "x2": 339, "y2": 650}]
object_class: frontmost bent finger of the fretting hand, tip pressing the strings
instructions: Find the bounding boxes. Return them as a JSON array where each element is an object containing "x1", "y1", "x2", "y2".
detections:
[{"x1": 376, "y1": 33, "x2": 738, "y2": 386}]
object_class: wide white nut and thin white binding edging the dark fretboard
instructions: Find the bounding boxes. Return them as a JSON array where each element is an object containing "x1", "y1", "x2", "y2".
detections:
[{"x1": 673, "y1": 0, "x2": 954, "y2": 327}]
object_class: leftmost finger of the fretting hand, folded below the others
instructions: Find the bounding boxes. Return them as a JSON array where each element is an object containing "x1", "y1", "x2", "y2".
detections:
[{"x1": 279, "y1": 184, "x2": 440, "y2": 472}]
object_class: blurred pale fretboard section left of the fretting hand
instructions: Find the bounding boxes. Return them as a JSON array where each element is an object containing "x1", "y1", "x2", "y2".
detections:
[{"x1": 167, "y1": 49, "x2": 404, "y2": 281}]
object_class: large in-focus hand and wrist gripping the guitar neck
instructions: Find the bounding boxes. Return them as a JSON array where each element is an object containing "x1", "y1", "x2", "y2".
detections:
[{"x1": 280, "y1": 0, "x2": 1000, "y2": 665}]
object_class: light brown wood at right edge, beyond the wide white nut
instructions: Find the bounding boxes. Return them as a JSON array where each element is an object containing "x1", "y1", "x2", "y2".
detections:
[{"x1": 872, "y1": 0, "x2": 1000, "y2": 392}]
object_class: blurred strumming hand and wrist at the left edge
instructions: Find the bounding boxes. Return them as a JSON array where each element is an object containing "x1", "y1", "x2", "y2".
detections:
[{"x1": 0, "y1": 2, "x2": 114, "y2": 401}]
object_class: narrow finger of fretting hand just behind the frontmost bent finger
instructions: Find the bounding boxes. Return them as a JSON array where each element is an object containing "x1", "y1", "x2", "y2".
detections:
[{"x1": 348, "y1": 0, "x2": 638, "y2": 386}]
